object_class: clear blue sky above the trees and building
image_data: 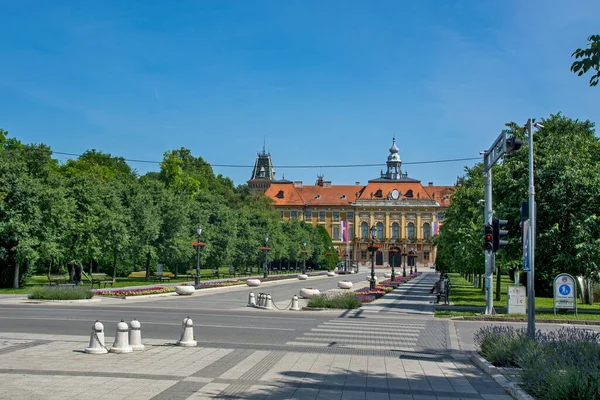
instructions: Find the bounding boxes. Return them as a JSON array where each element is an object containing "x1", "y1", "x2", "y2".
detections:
[{"x1": 0, "y1": 0, "x2": 600, "y2": 185}]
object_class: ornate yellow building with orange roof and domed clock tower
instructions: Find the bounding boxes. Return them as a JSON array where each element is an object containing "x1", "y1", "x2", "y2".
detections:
[{"x1": 253, "y1": 139, "x2": 454, "y2": 267}]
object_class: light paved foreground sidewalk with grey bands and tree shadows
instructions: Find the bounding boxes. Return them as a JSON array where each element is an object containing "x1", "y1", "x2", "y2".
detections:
[{"x1": 0, "y1": 332, "x2": 511, "y2": 400}]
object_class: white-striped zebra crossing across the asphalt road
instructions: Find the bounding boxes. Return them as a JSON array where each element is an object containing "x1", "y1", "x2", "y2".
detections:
[{"x1": 286, "y1": 318, "x2": 428, "y2": 350}]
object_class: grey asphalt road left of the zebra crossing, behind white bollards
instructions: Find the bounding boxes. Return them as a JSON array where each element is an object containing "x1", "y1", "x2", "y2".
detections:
[{"x1": 0, "y1": 272, "x2": 372, "y2": 344}]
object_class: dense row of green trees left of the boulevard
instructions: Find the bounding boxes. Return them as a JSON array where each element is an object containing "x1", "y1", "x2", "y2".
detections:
[{"x1": 0, "y1": 129, "x2": 337, "y2": 287}]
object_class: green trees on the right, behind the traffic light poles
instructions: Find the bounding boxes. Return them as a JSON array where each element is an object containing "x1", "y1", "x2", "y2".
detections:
[{"x1": 436, "y1": 114, "x2": 600, "y2": 295}]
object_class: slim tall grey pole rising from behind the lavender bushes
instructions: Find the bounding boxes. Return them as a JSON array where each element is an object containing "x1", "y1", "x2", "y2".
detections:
[{"x1": 527, "y1": 118, "x2": 536, "y2": 339}]
